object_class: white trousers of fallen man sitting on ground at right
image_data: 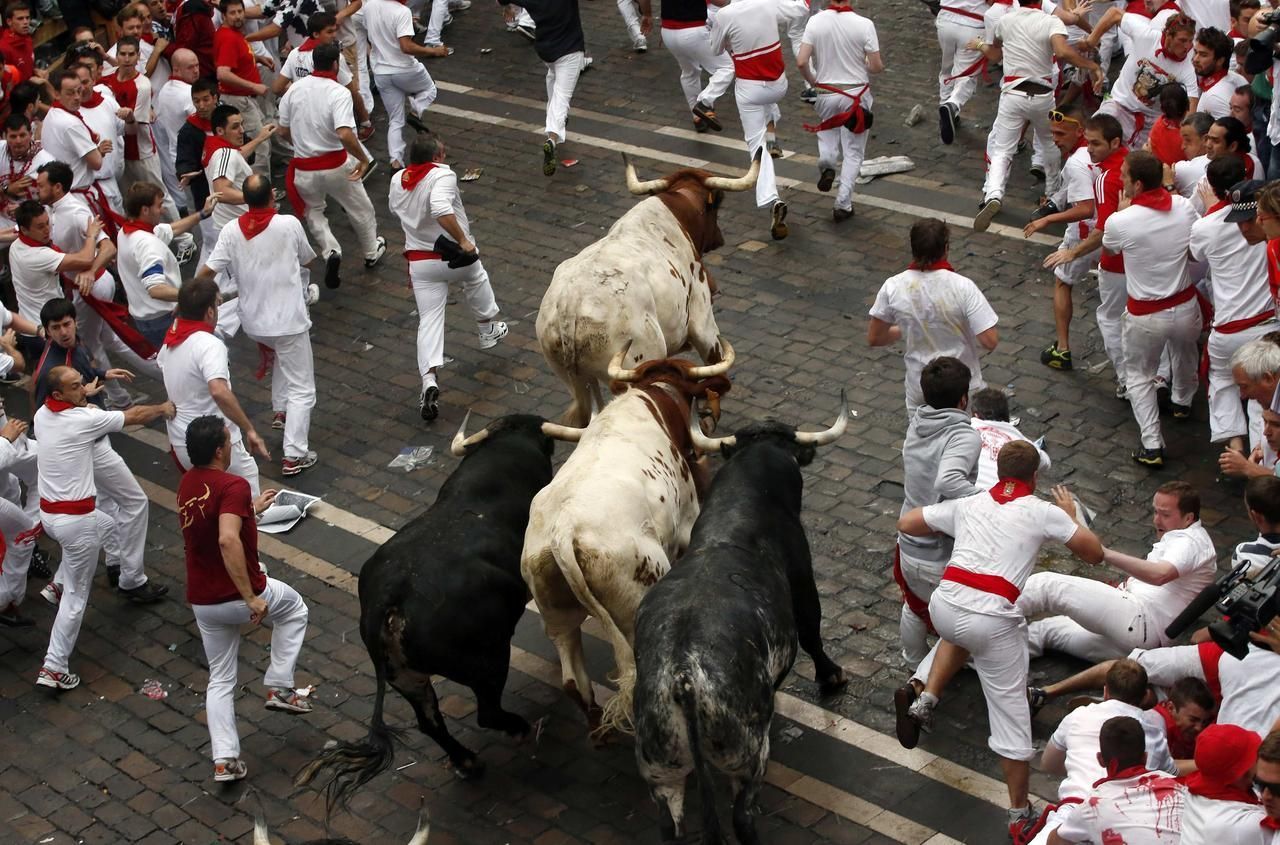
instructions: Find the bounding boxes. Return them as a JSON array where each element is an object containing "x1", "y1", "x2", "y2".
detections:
[{"x1": 1018, "y1": 572, "x2": 1164, "y2": 663}]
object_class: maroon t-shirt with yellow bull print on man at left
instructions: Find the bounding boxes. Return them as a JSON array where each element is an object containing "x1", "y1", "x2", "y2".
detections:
[{"x1": 178, "y1": 466, "x2": 266, "y2": 604}]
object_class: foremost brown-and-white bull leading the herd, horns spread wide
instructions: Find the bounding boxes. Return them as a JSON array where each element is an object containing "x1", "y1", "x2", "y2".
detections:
[{"x1": 538, "y1": 156, "x2": 760, "y2": 428}]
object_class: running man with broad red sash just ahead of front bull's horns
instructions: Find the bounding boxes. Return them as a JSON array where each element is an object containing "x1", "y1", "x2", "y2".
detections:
[{"x1": 709, "y1": 0, "x2": 809, "y2": 241}]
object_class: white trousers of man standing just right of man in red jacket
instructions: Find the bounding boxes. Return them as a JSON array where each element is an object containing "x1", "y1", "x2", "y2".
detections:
[{"x1": 1124, "y1": 300, "x2": 1201, "y2": 449}]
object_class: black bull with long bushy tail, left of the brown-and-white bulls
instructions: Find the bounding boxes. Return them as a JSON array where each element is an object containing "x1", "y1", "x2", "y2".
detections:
[{"x1": 298, "y1": 415, "x2": 580, "y2": 808}]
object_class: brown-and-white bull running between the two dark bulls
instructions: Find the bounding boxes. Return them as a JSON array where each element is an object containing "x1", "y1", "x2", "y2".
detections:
[{"x1": 520, "y1": 342, "x2": 733, "y2": 728}]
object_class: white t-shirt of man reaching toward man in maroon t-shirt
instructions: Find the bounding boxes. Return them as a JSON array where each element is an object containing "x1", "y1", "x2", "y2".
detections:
[{"x1": 35, "y1": 405, "x2": 124, "y2": 502}]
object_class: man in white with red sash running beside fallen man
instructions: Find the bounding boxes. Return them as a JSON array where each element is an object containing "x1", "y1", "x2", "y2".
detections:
[{"x1": 893, "y1": 440, "x2": 1102, "y2": 825}]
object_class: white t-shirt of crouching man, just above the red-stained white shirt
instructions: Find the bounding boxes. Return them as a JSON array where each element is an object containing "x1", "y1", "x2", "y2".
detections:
[{"x1": 1050, "y1": 698, "x2": 1178, "y2": 800}]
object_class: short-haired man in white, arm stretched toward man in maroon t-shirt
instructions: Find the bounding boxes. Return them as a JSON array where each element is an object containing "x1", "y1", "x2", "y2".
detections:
[{"x1": 35, "y1": 366, "x2": 174, "y2": 690}]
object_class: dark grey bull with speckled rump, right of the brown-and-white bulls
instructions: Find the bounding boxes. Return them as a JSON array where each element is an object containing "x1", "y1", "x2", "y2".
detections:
[{"x1": 634, "y1": 396, "x2": 849, "y2": 845}]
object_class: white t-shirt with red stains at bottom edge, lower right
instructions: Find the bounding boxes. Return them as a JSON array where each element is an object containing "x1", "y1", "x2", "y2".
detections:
[{"x1": 1057, "y1": 772, "x2": 1187, "y2": 845}]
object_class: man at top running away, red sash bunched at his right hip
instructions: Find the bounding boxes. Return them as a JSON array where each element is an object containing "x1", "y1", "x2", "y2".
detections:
[{"x1": 796, "y1": 0, "x2": 884, "y2": 223}]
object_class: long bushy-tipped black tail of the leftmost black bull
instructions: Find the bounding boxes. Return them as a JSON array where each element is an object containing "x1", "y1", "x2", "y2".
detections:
[{"x1": 293, "y1": 615, "x2": 399, "y2": 813}]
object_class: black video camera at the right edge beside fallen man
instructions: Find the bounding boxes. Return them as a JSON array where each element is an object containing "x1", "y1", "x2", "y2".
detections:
[{"x1": 1165, "y1": 551, "x2": 1280, "y2": 661}]
